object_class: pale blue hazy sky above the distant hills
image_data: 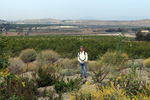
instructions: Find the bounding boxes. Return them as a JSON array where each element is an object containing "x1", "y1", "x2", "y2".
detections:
[{"x1": 0, "y1": 0, "x2": 150, "y2": 20}]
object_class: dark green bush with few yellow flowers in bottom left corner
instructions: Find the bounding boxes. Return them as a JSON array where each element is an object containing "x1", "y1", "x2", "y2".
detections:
[{"x1": 0, "y1": 75, "x2": 37, "y2": 100}]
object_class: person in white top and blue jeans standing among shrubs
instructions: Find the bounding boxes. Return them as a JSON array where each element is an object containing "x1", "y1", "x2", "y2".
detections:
[{"x1": 77, "y1": 46, "x2": 88, "y2": 78}]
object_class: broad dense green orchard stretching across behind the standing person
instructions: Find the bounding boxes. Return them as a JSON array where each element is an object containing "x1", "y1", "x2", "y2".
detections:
[{"x1": 1, "y1": 35, "x2": 150, "y2": 60}]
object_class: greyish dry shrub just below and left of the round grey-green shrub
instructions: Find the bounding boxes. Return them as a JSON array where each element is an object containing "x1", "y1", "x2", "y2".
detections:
[{"x1": 9, "y1": 58, "x2": 24, "y2": 74}]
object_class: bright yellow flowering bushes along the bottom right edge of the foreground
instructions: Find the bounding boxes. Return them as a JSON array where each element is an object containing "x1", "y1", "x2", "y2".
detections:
[{"x1": 69, "y1": 80, "x2": 150, "y2": 100}]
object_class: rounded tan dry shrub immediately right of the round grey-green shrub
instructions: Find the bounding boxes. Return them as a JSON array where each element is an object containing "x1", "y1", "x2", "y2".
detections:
[{"x1": 38, "y1": 50, "x2": 60, "y2": 65}]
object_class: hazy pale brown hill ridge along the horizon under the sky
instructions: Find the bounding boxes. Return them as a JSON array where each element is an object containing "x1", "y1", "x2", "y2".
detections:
[{"x1": 0, "y1": 18, "x2": 150, "y2": 27}]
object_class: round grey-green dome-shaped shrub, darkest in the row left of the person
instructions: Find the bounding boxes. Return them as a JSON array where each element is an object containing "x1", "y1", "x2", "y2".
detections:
[{"x1": 20, "y1": 49, "x2": 37, "y2": 63}]
